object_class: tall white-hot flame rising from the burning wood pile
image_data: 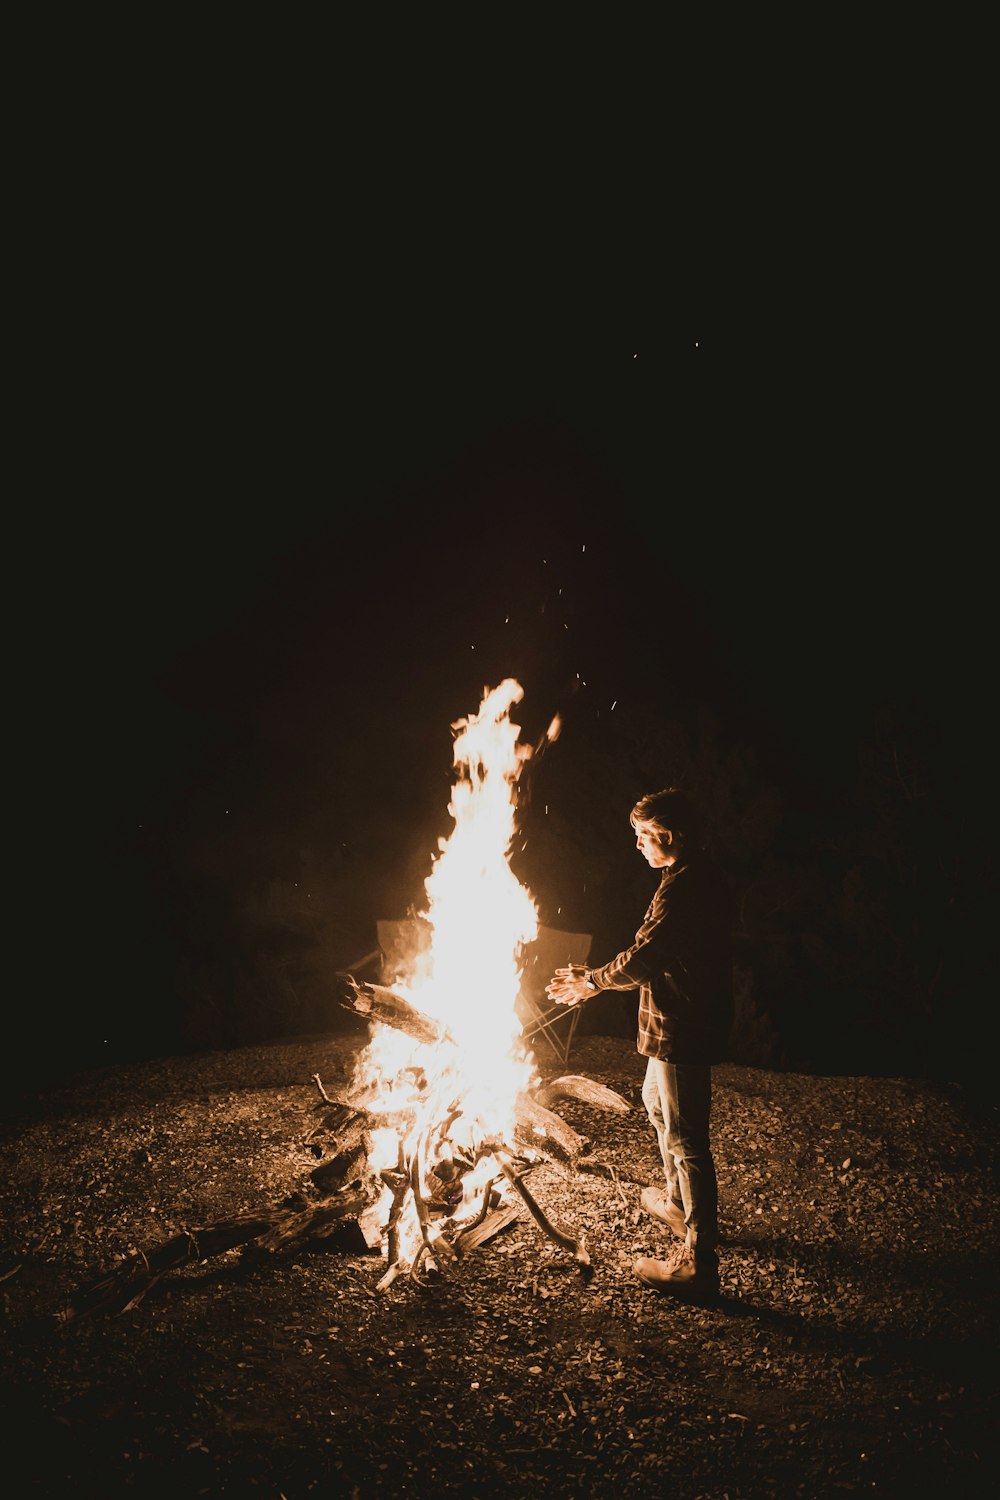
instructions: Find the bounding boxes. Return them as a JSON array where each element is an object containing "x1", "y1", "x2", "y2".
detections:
[{"x1": 358, "y1": 678, "x2": 538, "y2": 1241}]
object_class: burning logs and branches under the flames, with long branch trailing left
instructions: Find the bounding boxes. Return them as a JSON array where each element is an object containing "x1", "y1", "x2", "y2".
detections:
[{"x1": 43, "y1": 975, "x2": 631, "y2": 1325}]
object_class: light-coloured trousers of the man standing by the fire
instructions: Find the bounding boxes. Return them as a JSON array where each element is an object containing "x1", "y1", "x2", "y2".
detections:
[{"x1": 642, "y1": 1058, "x2": 718, "y2": 1251}]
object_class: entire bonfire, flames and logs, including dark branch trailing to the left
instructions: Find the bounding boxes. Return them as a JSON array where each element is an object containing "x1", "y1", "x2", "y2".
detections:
[{"x1": 46, "y1": 678, "x2": 631, "y2": 1323}]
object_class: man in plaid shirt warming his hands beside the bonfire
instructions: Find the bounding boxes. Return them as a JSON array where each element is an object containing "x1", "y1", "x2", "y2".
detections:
[{"x1": 547, "y1": 788, "x2": 733, "y2": 1298}]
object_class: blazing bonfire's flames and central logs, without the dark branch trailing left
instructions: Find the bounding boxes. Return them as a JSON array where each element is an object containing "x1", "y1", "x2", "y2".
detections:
[{"x1": 330, "y1": 678, "x2": 628, "y2": 1286}]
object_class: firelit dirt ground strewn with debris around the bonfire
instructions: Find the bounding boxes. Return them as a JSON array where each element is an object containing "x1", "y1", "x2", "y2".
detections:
[{"x1": 0, "y1": 1037, "x2": 1000, "y2": 1500}]
